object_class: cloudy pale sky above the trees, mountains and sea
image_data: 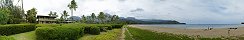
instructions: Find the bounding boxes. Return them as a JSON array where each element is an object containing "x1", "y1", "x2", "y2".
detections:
[{"x1": 14, "y1": 0, "x2": 244, "y2": 24}]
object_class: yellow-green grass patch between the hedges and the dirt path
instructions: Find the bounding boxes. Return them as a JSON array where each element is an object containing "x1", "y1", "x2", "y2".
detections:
[{"x1": 78, "y1": 29, "x2": 122, "y2": 40}]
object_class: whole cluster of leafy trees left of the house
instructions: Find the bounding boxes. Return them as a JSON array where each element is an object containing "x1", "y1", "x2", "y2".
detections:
[{"x1": 0, "y1": 0, "x2": 37, "y2": 24}]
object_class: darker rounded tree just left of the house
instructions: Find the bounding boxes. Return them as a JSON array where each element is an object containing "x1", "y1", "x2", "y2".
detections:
[{"x1": 26, "y1": 8, "x2": 37, "y2": 23}]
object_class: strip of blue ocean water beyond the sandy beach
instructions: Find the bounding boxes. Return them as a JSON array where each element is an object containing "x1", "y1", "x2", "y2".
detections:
[{"x1": 133, "y1": 24, "x2": 244, "y2": 29}]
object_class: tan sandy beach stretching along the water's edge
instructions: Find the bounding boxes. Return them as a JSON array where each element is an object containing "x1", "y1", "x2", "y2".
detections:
[{"x1": 128, "y1": 25, "x2": 244, "y2": 38}]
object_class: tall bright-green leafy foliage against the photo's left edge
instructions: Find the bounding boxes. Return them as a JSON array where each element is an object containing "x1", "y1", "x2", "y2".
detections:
[{"x1": 0, "y1": 0, "x2": 25, "y2": 24}]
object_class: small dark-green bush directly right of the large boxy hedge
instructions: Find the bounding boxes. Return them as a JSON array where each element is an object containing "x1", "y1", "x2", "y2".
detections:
[{"x1": 85, "y1": 26, "x2": 100, "y2": 35}]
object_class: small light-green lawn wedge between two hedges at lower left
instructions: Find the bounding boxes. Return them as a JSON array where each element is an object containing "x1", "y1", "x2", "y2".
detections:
[{"x1": 10, "y1": 31, "x2": 36, "y2": 40}]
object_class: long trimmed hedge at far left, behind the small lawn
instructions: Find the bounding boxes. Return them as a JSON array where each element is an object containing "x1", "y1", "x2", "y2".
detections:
[{"x1": 0, "y1": 24, "x2": 36, "y2": 35}]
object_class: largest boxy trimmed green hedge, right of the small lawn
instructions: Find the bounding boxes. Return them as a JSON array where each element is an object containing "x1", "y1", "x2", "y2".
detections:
[{"x1": 36, "y1": 26, "x2": 84, "y2": 40}]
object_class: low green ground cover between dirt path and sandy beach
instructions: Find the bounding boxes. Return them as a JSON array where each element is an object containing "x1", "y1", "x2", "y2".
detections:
[{"x1": 126, "y1": 27, "x2": 194, "y2": 40}]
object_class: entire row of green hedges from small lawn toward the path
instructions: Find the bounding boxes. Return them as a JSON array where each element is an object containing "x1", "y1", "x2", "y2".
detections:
[{"x1": 36, "y1": 24, "x2": 124, "y2": 40}]
